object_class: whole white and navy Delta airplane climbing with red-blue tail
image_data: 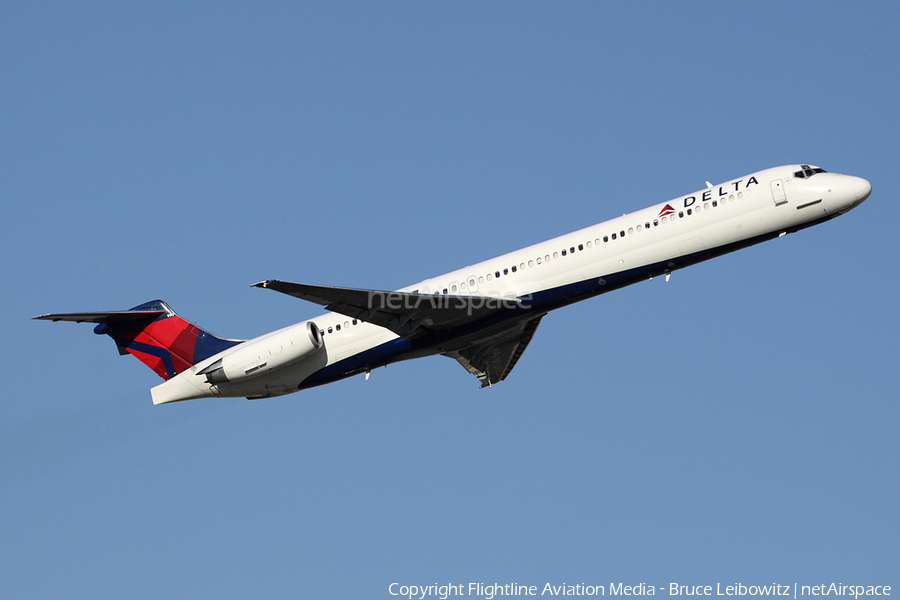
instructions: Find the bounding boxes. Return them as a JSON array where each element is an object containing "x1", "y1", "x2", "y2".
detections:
[{"x1": 35, "y1": 165, "x2": 872, "y2": 404}]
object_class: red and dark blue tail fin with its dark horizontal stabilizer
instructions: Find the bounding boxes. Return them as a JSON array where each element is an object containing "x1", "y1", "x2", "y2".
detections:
[{"x1": 35, "y1": 300, "x2": 243, "y2": 380}]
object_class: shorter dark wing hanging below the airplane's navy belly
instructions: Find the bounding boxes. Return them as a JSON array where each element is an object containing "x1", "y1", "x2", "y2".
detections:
[{"x1": 444, "y1": 315, "x2": 543, "y2": 387}]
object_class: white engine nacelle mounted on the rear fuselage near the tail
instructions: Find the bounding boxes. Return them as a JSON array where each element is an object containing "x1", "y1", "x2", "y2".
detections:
[{"x1": 197, "y1": 321, "x2": 324, "y2": 384}]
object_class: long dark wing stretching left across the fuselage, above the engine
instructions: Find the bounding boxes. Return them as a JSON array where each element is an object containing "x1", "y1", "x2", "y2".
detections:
[{"x1": 253, "y1": 279, "x2": 519, "y2": 339}]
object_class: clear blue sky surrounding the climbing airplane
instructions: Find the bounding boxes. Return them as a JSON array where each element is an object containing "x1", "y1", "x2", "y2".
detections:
[{"x1": 0, "y1": 2, "x2": 900, "y2": 599}]
